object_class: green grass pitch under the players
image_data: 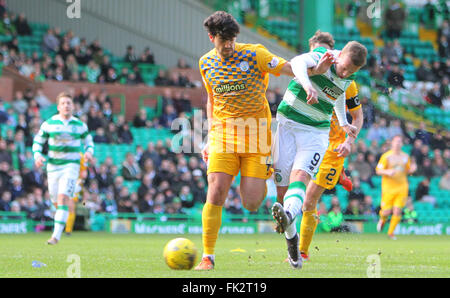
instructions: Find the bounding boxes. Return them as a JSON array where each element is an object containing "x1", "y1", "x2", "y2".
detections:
[{"x1": 0, "y1": 232, "x2": 450, "y2": 278}]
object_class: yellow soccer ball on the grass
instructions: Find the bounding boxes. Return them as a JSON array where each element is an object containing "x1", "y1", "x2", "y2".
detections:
[{"x1": 164, "y1": 238, "x2": 197, "y2": 270}]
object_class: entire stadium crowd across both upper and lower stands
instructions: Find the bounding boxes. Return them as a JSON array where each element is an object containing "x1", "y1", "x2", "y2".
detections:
[{"x1": 0, "y1": 0, "x2": 450, "y2": 230}]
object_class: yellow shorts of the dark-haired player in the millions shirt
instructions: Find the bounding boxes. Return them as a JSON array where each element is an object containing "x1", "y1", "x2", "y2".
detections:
[{"x1": 208, "y1": 152, "x2": 273, "y2": 179}]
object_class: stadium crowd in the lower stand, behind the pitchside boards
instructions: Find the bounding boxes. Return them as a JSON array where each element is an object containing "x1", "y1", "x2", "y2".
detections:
[{"x1": 0, "y1": 88, "x2": 450, "y2": 227}]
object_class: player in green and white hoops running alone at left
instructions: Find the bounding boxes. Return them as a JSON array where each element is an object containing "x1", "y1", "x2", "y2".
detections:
[{"x1": 32, "y1": 93, "x2": 94, "y2": 244}]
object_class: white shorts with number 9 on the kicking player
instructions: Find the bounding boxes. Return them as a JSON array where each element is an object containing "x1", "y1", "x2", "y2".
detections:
[{"x1": 272, "y1": 121, "x2": 329, "y2": 186}]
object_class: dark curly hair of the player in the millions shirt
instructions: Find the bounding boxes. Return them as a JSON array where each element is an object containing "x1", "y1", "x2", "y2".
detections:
[{"x1": 203, "y1": 11, "x2": 239, "y2": 40}]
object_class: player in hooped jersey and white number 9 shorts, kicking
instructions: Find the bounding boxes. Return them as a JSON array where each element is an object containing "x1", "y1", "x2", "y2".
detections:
[{"x1": 272, "y1": 41, "x2": 367, "y2": 268}]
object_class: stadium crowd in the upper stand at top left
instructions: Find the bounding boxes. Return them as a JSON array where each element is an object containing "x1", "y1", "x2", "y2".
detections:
[{"x1": 0, "y1": 4, "x2": 196, "y2": 87}]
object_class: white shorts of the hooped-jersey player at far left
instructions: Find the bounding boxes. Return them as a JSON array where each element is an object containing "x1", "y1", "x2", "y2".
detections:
[{"x1": 47, "y1": 164, "x2": 80, "y2": 203}]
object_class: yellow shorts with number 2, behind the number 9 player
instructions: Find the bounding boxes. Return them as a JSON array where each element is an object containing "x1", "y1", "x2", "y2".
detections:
[{"x1": 314, "y1": 147, "x2": 345, "y2": 189}]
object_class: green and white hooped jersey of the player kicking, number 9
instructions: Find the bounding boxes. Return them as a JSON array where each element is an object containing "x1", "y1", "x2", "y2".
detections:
[{"x1": 277, "y1": 47, "x2": 353, "y2": 131}]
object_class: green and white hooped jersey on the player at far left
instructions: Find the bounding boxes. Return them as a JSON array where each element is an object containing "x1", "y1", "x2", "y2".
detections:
[{"x1": 32, "y1": 115, "x2": 94, "y2": 171}]
